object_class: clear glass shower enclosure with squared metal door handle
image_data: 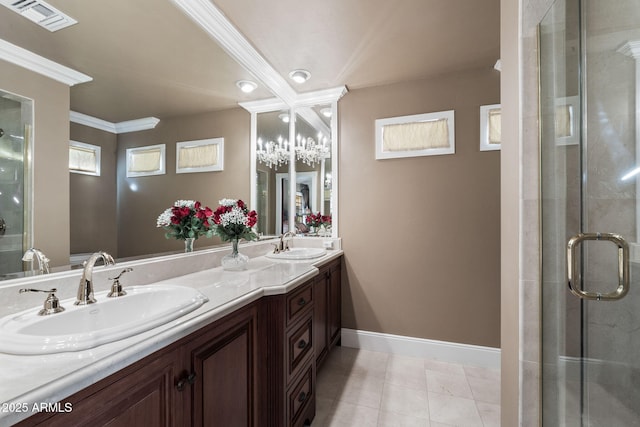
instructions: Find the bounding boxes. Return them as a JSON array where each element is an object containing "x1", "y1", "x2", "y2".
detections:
[{"x1": 539, "y1": 0, "x2": 640, "y2": 427}]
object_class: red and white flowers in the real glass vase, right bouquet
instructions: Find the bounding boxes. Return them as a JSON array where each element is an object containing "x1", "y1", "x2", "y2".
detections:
[{"x1": 213, "y1": 199, "x2": 258, "y2": 242}]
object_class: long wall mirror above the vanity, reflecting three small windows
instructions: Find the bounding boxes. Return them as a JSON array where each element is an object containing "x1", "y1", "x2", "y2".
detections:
[{"x1": 0, "y1": 0, "x2": 274, "y2": 279}]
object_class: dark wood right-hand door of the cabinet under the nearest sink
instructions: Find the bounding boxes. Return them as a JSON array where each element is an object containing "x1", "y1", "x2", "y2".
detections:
[{"x1": 189, "y1": 306, "x2": 257, "y2": 427}]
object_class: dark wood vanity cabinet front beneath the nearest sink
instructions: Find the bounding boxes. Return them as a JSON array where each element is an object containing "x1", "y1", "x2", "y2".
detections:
[{"x1": 19, "y1": 304, "x2": 257, "y2": 427}]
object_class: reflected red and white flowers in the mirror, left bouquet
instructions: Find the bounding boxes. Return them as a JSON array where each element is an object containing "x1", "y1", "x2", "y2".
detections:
[{"x1": 156, "y1": 200, "x2": 214, "y2": 240}]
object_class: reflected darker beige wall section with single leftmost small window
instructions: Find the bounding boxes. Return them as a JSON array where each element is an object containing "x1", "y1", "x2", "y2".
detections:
[{"x1": 69, "y1": 123, "x2": 118, "y2": 257}]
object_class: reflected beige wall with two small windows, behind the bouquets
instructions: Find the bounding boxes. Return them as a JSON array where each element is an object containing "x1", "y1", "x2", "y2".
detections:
[{"x1": 117, "y1": 108, "x2": 251, "y2": 257}]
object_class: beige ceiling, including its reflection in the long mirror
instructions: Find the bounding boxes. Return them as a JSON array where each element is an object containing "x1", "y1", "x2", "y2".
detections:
[{"x1": 0, "y1": 0, "x2": 500, "y2": 122}]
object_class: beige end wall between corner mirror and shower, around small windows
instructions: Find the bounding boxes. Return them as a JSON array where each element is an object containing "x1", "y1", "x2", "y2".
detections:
[{"x1": 339, "y1": 68, "x2": 500, "y2": 347}]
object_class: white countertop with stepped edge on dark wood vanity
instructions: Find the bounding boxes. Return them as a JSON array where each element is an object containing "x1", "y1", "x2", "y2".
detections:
[{"x1": 0, "y1": 250, "x2": 342, "y2": 426}]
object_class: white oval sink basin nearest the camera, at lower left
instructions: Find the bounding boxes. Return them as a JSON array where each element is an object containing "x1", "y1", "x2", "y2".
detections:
[{"x1": 0, "y1": 285, "x2": 208, "y2": 354}]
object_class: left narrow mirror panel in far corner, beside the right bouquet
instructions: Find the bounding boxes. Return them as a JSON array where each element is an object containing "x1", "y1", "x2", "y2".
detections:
[{"x1": 256, "y1": 111, "x2": 290, "y2": 235}]
